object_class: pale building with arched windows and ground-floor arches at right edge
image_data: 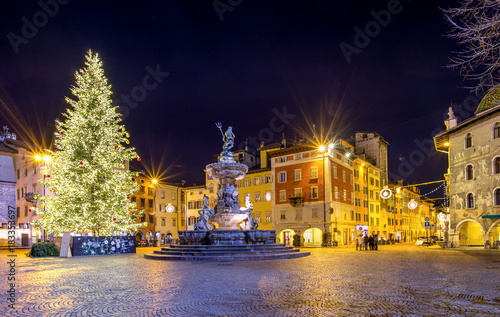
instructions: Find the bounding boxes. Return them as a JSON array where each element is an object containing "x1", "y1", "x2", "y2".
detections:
[{"x1": 434, "y1": 86, "x2": 500, "y2": 247}]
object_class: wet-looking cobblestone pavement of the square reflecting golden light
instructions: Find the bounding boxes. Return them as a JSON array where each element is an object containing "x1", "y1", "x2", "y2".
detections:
[{"x1": 0, "y1": 245, "x2": 500, "y2": 316}]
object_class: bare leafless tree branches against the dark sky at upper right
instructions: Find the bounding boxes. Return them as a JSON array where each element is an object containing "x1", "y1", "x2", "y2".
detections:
[{"x1": 443, "y1": 0, "x2": 500, "y2": 94}]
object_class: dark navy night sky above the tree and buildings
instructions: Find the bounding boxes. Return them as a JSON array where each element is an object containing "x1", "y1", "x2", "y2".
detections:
[{"x1": 0, "y1": 0, "x2": 477, "y2": 195}]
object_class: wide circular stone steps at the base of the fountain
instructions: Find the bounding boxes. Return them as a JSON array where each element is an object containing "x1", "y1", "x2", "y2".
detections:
[{"x1": 144, "y1": 244, "x2": 310, "y2": 261}]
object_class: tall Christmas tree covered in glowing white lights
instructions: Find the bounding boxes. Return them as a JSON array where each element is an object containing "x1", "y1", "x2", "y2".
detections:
[{"x1": 35, "y1": 51, "x2": 144, "y2": 235}]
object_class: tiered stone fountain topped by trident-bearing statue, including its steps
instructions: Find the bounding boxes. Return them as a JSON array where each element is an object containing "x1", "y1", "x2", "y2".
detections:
[{"x1": 144, "y1": 123, "x2": 310, "y2": 261}]
